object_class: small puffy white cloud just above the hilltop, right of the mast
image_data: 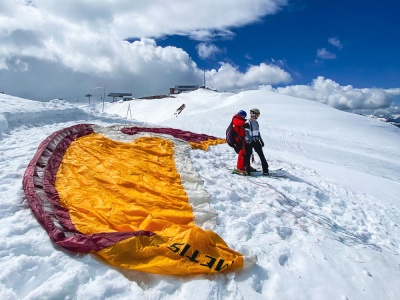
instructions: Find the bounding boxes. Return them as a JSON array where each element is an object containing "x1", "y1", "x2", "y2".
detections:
[{"x1": 206, "y1": 63, "x2": 292, "y2": 91}]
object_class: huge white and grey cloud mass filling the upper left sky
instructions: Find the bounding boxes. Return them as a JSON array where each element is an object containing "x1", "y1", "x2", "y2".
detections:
[{"x1": 0, "y1": 0, "x2": 288, "y2": 97}]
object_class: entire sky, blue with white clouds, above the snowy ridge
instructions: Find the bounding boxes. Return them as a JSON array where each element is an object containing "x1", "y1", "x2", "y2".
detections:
[{"x1": 0, "y1": 0, "x2": 400, "y2": 114}]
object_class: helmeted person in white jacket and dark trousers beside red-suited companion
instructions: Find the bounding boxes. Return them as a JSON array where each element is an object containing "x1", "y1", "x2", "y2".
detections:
[{"x1": 244, "y1": 108, "x2": 269, "y2": 175}]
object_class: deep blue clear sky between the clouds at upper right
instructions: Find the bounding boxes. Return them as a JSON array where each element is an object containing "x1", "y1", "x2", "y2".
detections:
[{"x1": 157, "y1": 0, "x2": 400, "y2": 88}]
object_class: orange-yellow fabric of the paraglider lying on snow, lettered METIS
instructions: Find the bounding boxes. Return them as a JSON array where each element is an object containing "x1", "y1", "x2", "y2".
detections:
[{"x1": 23, "y1": 124, "x2": 253, "y2": 275}]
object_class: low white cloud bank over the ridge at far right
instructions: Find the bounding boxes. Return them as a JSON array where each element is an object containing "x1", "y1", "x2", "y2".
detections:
[{"x1": 265, "y1": 76, "x2": 393, "y2": 111}]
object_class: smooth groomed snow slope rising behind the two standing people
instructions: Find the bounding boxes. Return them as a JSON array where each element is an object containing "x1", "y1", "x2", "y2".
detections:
[{"x1": 106, "y1": 89, "x2": 400, "y2": 203}]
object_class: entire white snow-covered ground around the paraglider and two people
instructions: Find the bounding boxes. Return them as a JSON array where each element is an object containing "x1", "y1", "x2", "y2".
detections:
[{"x1": 0, "y1": 90, "x2": 400, "y2": 300}]
